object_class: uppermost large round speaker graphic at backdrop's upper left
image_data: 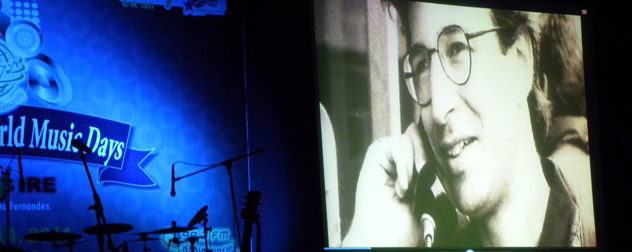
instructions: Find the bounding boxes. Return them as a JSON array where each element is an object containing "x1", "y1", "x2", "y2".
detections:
[{"x1": 5, "y1": 20, "x2": 44, "y2": 58}]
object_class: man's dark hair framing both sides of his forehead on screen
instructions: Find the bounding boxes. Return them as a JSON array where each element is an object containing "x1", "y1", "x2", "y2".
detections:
[{"x1": 383, "y1": 0, "x2": 552, "y2": 155}]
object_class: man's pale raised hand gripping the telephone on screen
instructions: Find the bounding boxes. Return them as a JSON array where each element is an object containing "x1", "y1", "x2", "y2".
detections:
[{"x1": 343, "y1": 124, "x2": 427, "y2": 247}]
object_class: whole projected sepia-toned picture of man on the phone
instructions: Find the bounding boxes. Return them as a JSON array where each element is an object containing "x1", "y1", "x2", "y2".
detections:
[{"x1": 314, "y1": 0, "x2": 597, "y2": 248}]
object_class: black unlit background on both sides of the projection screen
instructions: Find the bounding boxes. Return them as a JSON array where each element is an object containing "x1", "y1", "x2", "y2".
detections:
[{"x1": 238, "y1": 0, "x2": 632, "y2": 251}]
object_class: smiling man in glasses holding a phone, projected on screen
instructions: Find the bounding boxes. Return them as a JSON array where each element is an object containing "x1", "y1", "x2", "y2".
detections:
[{"x1": 343, "y1": 1, "x2": 596, "y2": 247}]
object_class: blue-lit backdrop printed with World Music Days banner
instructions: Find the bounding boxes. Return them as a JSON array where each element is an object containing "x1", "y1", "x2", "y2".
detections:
[{"x1": 0, "y1": 0, "x2": 255, "y2": 251}]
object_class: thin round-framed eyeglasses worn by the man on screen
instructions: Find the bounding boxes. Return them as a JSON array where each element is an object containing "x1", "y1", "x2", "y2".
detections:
[{"x1": 403, "y1": 25, "x2": 502, "y2": 106}]
